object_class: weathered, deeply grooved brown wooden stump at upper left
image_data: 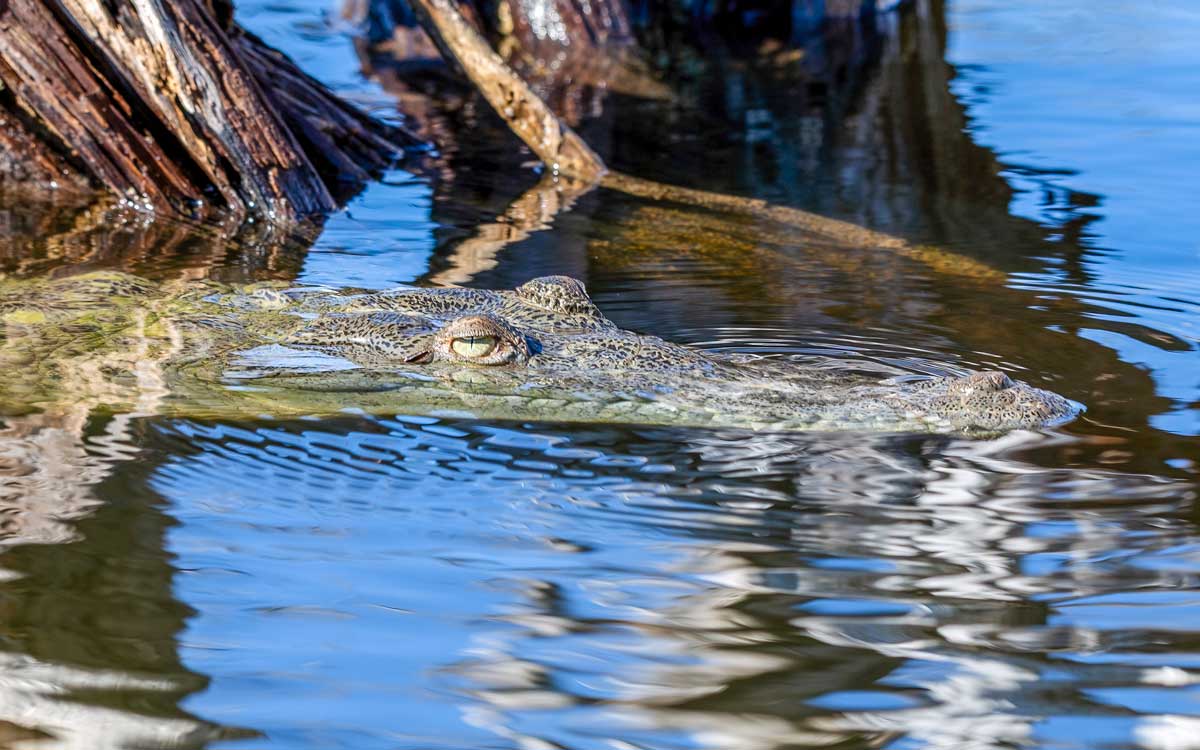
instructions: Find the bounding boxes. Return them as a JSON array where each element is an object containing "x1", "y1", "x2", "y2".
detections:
[{"x1": 0, "y1": 0, "x2": 418, "y2": 223}]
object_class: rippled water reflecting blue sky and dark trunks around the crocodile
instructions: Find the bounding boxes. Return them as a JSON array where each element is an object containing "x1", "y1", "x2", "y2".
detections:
[{"x1": 0, "y1": 0, "x2": 1200, "y2": 750}]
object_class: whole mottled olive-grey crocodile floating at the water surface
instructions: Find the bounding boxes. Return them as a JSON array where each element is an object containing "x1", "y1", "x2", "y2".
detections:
[{"x1": 0, "y1": 272, "x2": 1081, "y2": 436}]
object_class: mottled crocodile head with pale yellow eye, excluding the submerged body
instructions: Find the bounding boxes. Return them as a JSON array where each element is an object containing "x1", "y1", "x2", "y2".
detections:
[{"x1": 225, "y1": 276, "x2": 1079, "y2": 434}]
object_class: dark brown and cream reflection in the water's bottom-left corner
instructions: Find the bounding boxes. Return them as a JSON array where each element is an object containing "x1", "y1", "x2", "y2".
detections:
[{"x1": 0, "y1": 407, "x2": 223, "y2": 750}]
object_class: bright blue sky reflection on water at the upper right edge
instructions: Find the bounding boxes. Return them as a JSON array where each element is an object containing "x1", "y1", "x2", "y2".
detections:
[{"x1": 947, "y1": 0, "x2": 1200, "y2": 436}]
